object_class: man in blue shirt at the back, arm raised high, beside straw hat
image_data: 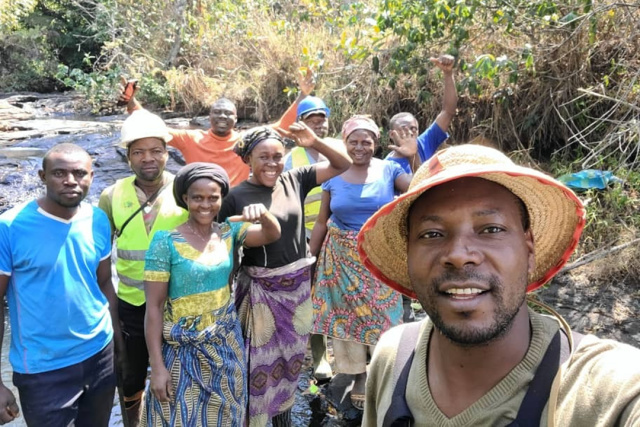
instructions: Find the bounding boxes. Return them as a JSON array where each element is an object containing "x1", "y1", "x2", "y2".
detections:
[{"x1": 387, "y1": 55, "x2": 458, "y2": 173}]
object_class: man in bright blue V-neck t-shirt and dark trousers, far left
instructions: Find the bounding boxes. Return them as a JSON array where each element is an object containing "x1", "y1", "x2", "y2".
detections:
[{"x1": 0, "y1": 143, "x2": 122, "y2": 427}]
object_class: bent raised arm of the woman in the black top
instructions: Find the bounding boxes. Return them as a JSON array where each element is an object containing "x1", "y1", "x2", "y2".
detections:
[{"x1": 289, "y1": 122, "x2": 351, "y2": 185}]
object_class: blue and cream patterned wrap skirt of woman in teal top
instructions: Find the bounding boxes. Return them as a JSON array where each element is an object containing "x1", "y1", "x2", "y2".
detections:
[{"x1": 141, "y1": 297, "x2": 247, "y2": 427}]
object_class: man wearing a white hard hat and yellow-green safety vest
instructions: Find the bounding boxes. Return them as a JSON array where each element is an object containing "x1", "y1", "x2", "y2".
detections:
[{"x1": 98, "y1": 110, "x2": 187, "y2": 427}]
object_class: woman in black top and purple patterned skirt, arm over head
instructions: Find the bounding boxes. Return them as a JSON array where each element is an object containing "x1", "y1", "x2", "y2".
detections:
[{"x1": 220, "y1": 123, "x2": 350, "y2": 427}]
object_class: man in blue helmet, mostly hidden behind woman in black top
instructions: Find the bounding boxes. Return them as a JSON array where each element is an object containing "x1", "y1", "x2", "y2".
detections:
[{"x1": 284, "y1": 96, "x2": 342, "y2": 381}]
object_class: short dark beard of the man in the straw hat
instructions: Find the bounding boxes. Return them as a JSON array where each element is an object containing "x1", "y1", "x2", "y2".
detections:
[{"x1": 424, "y1": 271, "x2": 527, "y2": 347}]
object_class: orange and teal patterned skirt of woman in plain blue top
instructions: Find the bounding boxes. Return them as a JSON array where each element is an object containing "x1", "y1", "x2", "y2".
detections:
[{"x1": 313, "y1": 221, "x2": 402, "y2": 345}]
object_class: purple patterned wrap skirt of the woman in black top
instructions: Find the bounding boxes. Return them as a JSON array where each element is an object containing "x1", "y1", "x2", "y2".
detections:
[{"x1": 236, "y1": 258, "x2": 315, "y2": 427}]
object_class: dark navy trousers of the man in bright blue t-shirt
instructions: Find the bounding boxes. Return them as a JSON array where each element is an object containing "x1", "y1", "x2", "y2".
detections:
[{"x1": 13, "y1": 342, "x2": 116, "y2": 427}]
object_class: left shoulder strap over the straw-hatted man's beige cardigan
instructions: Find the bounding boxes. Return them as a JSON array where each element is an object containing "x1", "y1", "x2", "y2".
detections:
[{"x1": 382, "y1": 322, "x2": 422, "y2": 427}]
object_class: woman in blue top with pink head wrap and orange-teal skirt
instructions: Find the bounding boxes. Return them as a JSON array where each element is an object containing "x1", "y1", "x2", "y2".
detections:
[{"x1": 309, "y1": 116, "x2": 417, "y2": 409}]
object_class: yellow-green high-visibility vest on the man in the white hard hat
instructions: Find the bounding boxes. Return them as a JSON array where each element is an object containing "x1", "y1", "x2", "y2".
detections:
[{"x1": 111, "y1": 176, "x2": 189, "y2": 306}]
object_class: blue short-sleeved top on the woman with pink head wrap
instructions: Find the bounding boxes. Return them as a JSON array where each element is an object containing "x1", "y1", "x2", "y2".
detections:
[{"x1": 322, "y1": 159, "x2": 405, "y2": 231}]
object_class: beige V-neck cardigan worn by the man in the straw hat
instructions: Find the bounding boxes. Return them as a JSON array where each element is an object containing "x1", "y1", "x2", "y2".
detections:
[{"x1": 362, "y1": 310, "x2": 640, "y2": 427}]
